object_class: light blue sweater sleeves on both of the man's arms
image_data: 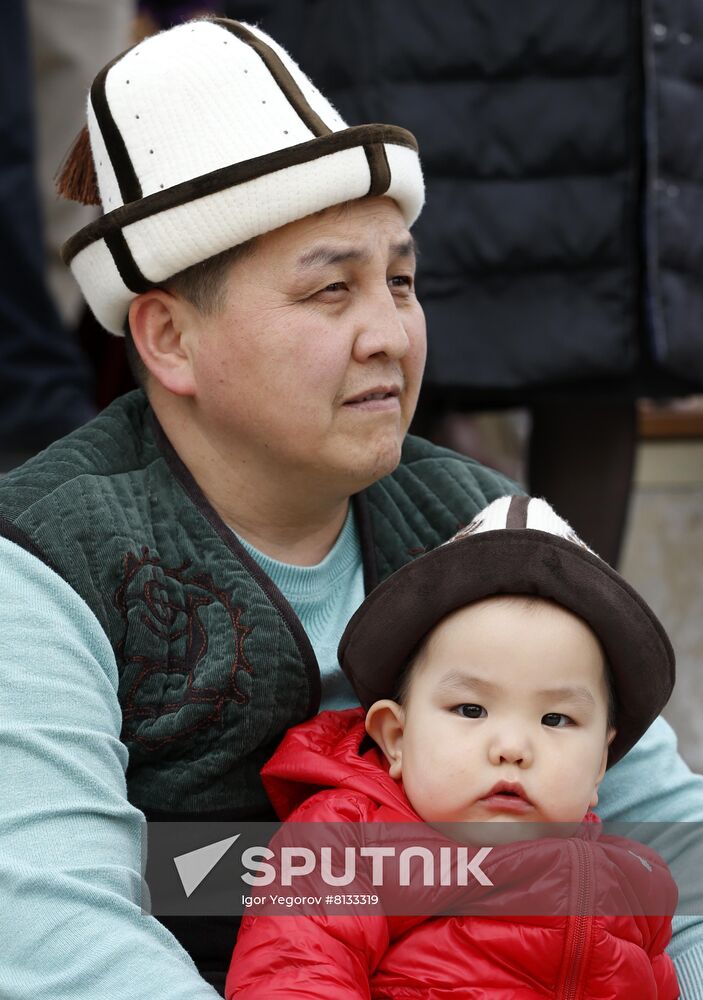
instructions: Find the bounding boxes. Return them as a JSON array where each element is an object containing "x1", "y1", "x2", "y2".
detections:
[{"x1": 0, "y1": 538, "x2": 703, "y2": 1000}]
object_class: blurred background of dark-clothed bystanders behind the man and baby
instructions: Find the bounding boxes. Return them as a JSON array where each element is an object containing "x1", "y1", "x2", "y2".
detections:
[{"x1": 0, "y1": 0, "x2": 703, "y2": 771}]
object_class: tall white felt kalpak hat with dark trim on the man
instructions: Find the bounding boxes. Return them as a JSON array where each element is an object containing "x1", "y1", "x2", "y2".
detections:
[{"x1": 63, "y1": 18, "x2": 424, "y2": 335}]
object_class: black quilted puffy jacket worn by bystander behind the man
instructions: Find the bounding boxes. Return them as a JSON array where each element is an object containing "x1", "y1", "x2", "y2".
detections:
[{"x1": 228, "y1": 0, "x2": 703, "y2": 403}]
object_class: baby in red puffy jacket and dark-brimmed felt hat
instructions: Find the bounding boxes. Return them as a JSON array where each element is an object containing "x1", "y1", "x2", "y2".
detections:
[{"x1": 226, "y1": 497, "x2": 678, "y2": 1000}]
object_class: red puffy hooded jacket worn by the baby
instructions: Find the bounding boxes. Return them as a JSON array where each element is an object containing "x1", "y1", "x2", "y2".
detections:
[{"x1": 226, "y1": 709, "x2": 679, "y2": 1000}]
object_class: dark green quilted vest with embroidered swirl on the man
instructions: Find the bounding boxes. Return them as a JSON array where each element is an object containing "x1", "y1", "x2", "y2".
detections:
[{"x1": 0, "y1": 392, "x2": 515, "y2": 819}]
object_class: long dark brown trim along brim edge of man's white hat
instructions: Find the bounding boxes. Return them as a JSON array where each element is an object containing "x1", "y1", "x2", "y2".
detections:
[{"x1": 61, "y1": 125, "x2": 417, "y2": 264}]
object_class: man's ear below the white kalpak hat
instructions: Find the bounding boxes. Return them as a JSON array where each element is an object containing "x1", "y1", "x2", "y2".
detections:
[{"x1": 129, "y1": 288, "x2": 195, "y2": 396}]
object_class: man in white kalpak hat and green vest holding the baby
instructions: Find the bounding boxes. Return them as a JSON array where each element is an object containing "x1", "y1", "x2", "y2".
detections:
[{"x1": 0, "y1": 20, "x2": 703, "y2": 1000}]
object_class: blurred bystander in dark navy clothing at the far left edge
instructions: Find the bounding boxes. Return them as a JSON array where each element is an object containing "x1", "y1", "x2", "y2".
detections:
[{"x1": 0, "y1": 2, "x2": 96, "y2": 473}]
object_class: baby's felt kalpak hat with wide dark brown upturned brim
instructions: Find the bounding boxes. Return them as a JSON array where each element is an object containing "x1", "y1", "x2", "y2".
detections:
[{"x1": 339, "y1": 496, "x2": 675, "y2": 767}]
